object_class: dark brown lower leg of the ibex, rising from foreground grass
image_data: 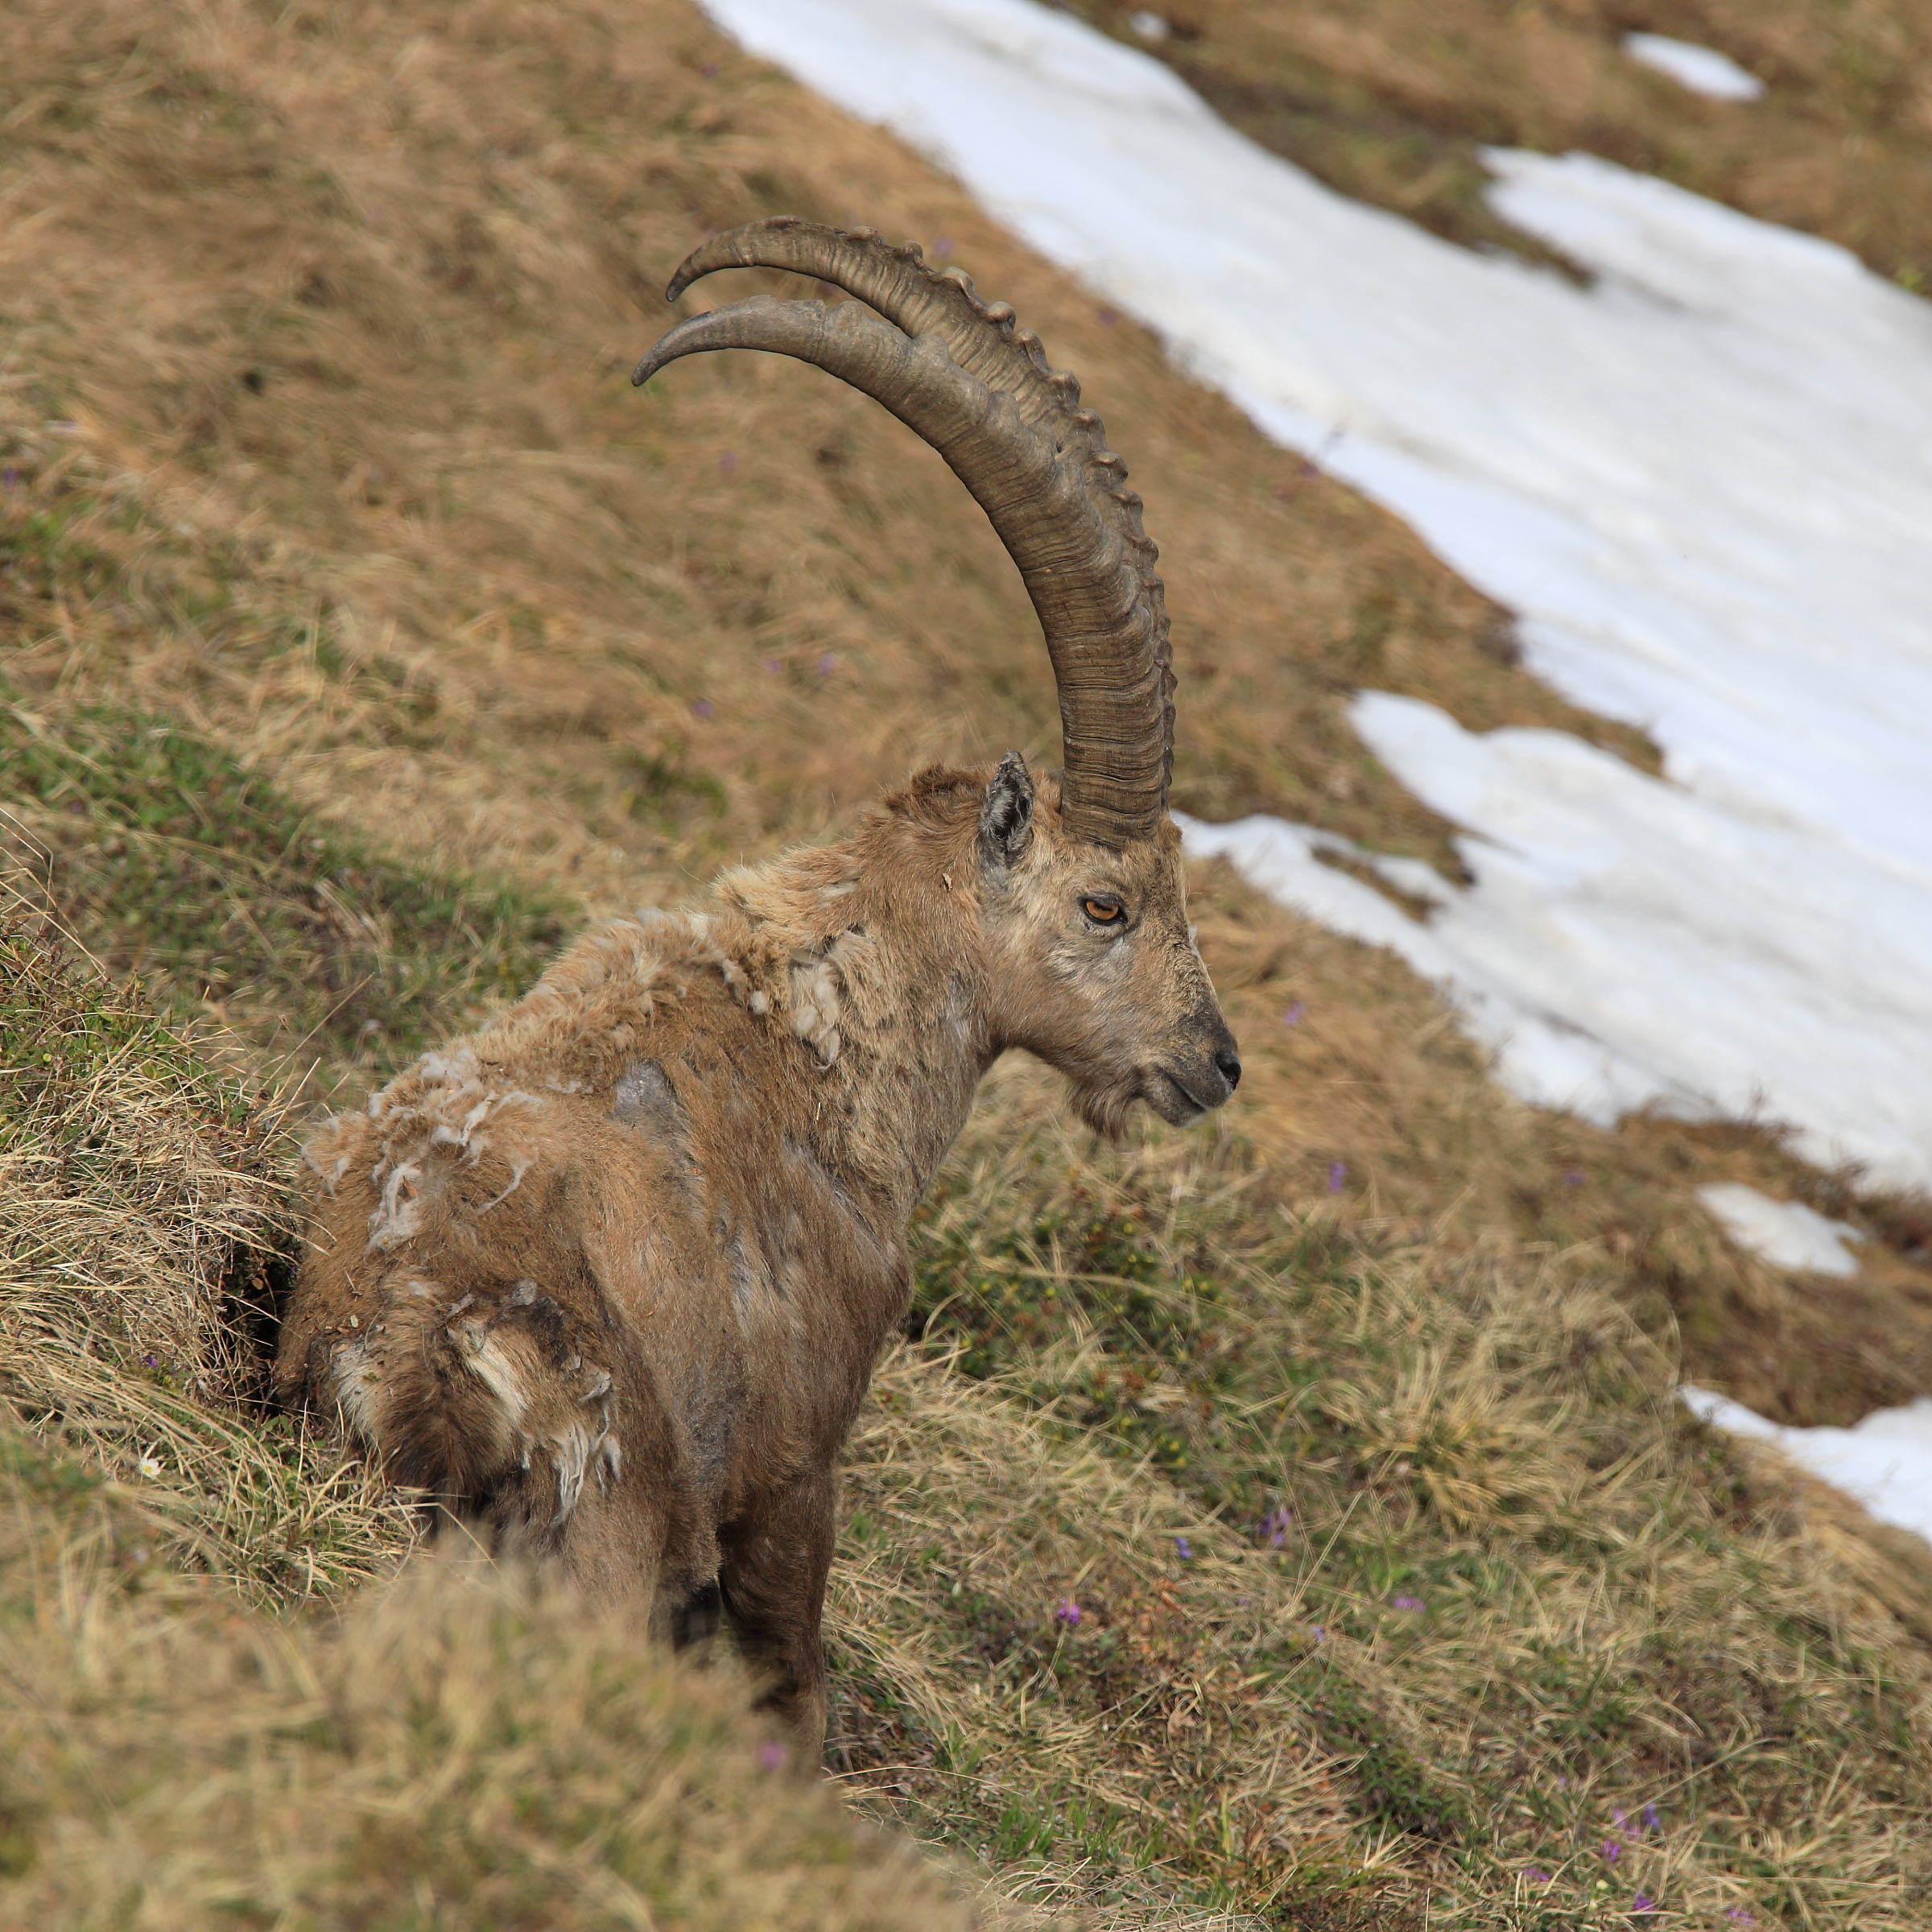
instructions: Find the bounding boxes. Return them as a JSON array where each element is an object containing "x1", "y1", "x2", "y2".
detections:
[{"x1": 719, "y1": 1470, "x2": 836, "y2": 1769}]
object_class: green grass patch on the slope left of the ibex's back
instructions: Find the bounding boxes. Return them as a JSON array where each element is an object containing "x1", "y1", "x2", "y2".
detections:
[{"x1": 0, "y1": 694, "x2": 568, "y2": 1076}]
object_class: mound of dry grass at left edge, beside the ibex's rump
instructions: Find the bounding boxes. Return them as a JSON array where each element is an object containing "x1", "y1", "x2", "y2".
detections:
[{"x1": 0, "y1": 900, "x2": 411, "y2": 1602}]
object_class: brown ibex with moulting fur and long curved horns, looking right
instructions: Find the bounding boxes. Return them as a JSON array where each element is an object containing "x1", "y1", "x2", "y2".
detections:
[{"x1": 276, "y1": 218, "x2": 1241, "y2": 1764}]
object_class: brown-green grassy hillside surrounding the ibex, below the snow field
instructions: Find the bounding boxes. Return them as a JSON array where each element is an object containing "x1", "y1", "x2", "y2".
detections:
[{"x1": 0, "y1": 0, "x2": 1932, "y2": 1928}]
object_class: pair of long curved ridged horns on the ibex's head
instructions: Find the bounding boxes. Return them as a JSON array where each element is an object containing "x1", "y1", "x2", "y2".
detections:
[{"x1": 632, "y1": 217, "x2": 1174, "y2": 848}]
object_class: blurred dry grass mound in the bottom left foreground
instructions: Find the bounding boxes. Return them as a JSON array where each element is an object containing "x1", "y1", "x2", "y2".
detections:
[{"x1": 0, "y1": 1430, "x2": 985, "y2": 1932}]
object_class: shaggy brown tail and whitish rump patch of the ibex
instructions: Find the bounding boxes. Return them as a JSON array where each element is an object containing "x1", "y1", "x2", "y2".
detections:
[{"x1": 308, "y1": 1269, "x2": 620, "y2": 1550}]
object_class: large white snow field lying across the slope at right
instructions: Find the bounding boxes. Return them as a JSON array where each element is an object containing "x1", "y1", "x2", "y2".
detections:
[{"x1": 704, "y1": 0, "x2": 1932, "y2": 1536}]
